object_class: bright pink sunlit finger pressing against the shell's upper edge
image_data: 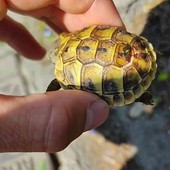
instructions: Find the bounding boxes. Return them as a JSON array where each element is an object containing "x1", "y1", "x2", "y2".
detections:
[{"x1": 49, "y1": 0, "x2": 124, "y2": 32}]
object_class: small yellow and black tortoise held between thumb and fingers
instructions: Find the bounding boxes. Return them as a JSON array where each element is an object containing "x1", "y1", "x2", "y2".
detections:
[{"x1": 47, "y1": 26, "x2": 157, "y2": 106}]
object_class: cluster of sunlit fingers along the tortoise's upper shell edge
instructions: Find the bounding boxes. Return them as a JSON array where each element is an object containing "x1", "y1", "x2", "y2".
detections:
[{"x1": 7, "y1": 0, "x2": 124, "y2": 32}]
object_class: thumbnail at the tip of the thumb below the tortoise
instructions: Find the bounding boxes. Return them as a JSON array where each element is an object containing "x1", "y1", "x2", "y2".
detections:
[{"x1": 85, "y1": 99, "x2": 109, "y2": 131}]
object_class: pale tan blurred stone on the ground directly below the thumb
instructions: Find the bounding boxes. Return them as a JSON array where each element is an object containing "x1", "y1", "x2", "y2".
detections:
[{"x1": 57, "y1": 131, "x2": 137, "y2": 170}]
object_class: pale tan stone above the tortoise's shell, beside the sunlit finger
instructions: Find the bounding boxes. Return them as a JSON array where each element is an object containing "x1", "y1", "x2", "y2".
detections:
[{"x1": 114, "y1": 0, "x2": 164, "y2": 34}]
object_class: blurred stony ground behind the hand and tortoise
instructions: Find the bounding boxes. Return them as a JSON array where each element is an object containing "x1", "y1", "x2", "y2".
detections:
[{"x1": 0, "y1": 0, "x2": 170, "y2": 170}]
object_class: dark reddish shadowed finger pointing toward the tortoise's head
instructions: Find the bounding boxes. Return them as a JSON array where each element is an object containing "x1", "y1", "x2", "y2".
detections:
[{"x1": 0, "y1": 17, "x2": 45, "y2": 59}]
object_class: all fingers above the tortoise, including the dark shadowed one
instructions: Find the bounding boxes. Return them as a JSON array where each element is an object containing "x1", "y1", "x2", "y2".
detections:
[{"x1": 0, "y1": 0, "x2": 123, "y2": 59}]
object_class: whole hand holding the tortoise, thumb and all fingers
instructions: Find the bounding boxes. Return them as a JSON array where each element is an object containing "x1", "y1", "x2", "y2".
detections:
[{"x1": 0, "y1": 0, "x2": 123, "y2": 152}]
